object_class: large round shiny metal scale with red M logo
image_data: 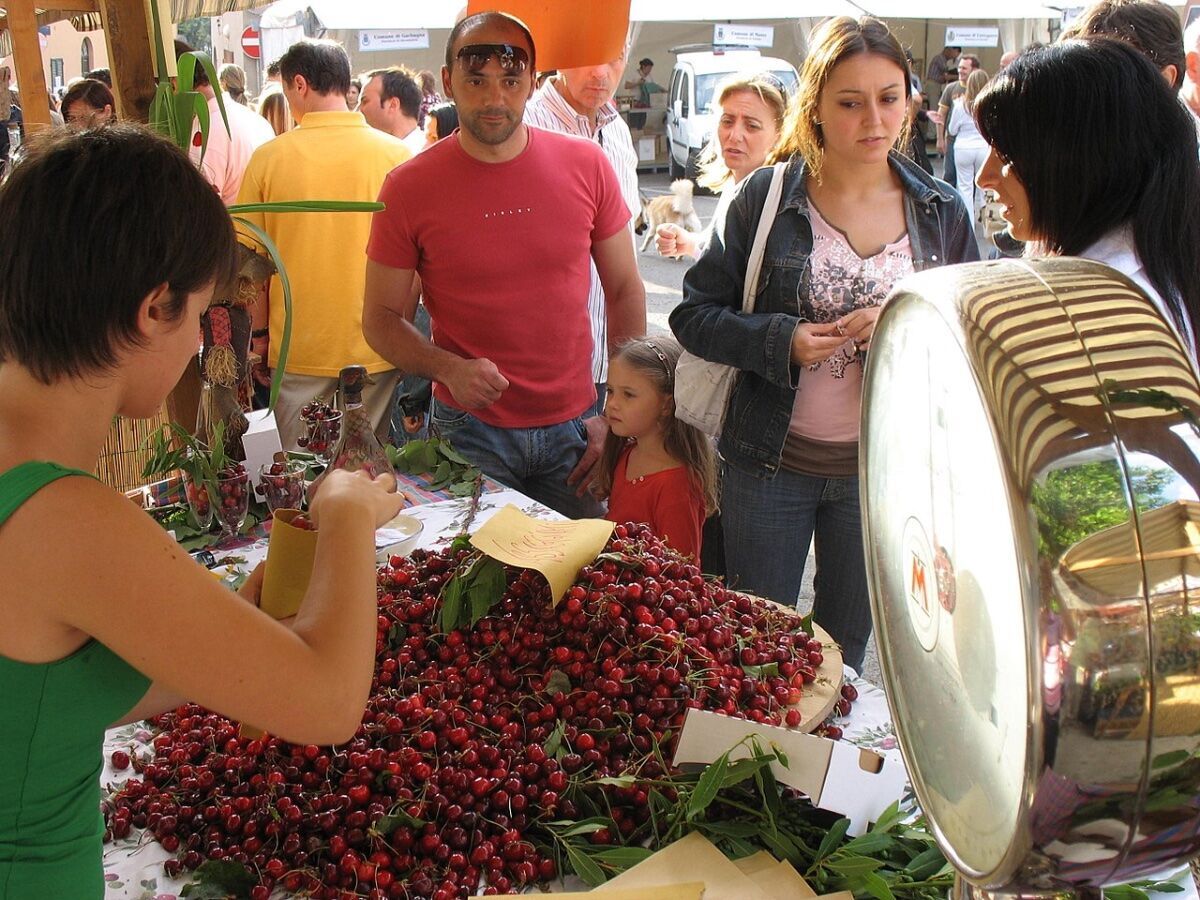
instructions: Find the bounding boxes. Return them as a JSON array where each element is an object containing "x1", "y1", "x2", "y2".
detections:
[{"x1": 860, "y1": 259, "x2": 1200, "y2": 896}]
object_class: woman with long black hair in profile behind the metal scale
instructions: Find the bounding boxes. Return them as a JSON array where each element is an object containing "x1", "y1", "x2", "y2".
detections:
[{"x1": 976, "y1": 37, "x2": 1200, "y2": 358}]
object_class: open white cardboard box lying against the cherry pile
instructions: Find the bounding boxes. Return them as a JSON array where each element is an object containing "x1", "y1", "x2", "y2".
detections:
[{"x1": 674, "y1": 709, "x2": 907, "y2": 835}]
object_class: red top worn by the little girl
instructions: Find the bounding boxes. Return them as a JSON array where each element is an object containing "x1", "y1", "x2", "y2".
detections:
[{"x1": 605, "y1": 446, "x2": 704, "y2": 565}]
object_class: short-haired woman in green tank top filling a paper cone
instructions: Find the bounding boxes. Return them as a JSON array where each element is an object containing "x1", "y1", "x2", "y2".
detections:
[{"x1": 0, "y1": 124, "x2": 401, "y2": 898}]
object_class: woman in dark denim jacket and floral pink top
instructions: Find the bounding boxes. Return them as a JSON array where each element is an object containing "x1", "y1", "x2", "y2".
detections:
[{"x1": 671, "y1": 17, "x2": 979, "y2": 668}]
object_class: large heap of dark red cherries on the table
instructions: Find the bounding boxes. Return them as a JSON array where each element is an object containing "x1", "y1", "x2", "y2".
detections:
[{"x1": 107, "y1": 524, "x2": 856, "y2": 900}]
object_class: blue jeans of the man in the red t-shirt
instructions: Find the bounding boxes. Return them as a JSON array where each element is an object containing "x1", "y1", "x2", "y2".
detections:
[{"x1": 430, "y1": 397, "x2": 604, "y2": 518}]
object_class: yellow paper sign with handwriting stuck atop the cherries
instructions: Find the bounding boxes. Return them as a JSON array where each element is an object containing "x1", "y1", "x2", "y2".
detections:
[{"x1": 470, "y1": 505, "x2": 613, "y2": 604}]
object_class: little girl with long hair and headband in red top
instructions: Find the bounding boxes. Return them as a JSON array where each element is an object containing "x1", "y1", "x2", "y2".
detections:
[{"x1": 600, "y1": 337, "x2": 716, "y2": 565}]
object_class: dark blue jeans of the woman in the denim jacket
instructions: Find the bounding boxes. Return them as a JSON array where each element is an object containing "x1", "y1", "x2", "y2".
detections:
[{"x1": 721, "y1": 466, "x2": 871, "y2": 671}]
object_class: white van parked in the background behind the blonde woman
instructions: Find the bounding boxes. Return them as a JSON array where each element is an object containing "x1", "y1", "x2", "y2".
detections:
[{"x1": 667, "y1": 46, "x2": 799, "y2": 180}]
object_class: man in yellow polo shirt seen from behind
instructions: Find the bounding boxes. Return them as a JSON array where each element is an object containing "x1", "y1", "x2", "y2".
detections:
[{"x1": 238, "y1": 41, "x2": 412, "y2": 449}]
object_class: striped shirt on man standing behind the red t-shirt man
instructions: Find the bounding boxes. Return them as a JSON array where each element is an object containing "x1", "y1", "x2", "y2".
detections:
[{"x1": 524, "y1": 78, "x2": 642, "y2": 384}]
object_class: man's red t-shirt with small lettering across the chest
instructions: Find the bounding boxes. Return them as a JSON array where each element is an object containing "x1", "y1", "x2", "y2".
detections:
[{"x1": 367, "y1": 127, "x2": 629, "y2": 428}]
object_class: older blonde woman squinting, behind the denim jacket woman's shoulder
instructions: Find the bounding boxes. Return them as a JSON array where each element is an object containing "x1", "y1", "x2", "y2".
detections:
[{"x1": 655, "y1": 72, "x2": 787, "y2": 257}]
